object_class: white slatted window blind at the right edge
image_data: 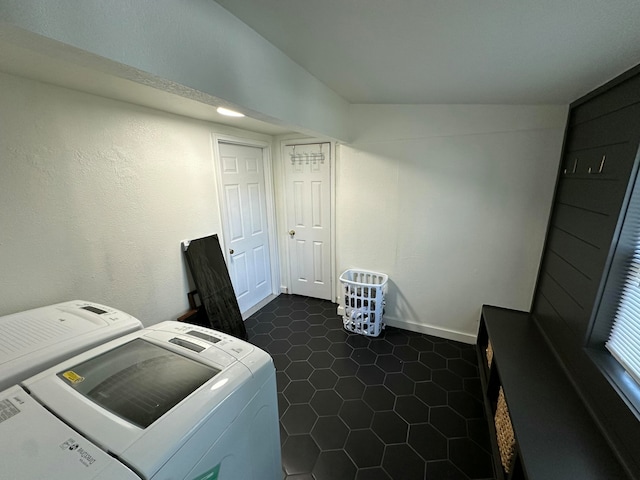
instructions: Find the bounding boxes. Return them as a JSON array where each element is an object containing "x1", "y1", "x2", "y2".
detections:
[{"x1": 606, "y1": 205, "x2": 640, "y2": 384}]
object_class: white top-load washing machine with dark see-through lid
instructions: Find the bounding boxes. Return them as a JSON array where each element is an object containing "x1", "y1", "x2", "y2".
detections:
[{"x1": 0, "y1": 322, "x2": 282, "y2": 480}]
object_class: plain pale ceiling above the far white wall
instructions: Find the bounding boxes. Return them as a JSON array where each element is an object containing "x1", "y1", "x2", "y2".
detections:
[{"x1": 216, "y1": 0, "x2": 640, "y2": 104}]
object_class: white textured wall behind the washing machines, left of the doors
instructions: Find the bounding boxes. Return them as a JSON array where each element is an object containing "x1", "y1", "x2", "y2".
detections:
[{"x1": 0, "y1": 74, "x2": 271, "y2": 325}]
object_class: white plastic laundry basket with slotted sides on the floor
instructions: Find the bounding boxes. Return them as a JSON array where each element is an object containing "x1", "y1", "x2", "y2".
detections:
[{"x1": 340, "y1": 269, "x2": 389, "y2": 337}]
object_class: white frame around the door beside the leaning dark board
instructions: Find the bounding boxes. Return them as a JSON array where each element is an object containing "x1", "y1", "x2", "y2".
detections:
[{"x1": 211, "y1": 133, "x2": 280, "y2": 320}]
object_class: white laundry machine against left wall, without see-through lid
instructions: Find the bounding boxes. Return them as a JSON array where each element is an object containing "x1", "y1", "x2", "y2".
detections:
[{"x1": 0, "y1": 300, "x2": 142, "y2": 390}]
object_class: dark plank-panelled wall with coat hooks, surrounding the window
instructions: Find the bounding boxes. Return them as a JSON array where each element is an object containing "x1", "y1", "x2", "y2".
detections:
[{"x1": 531, "y1": 67, "x2": 640, "y2": 478}]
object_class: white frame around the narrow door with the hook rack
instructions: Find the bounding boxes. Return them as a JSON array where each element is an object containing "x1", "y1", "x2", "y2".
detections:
[{"x1": 278, "y1": 137, "x2": 340, "y2": 303}]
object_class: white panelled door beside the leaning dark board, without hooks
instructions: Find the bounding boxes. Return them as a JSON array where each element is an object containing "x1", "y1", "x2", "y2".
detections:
[{"x1": 218, "y1": 142, "x2": 271, "y2": 313}]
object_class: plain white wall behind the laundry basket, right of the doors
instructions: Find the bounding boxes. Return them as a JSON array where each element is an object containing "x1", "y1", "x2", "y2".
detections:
[{"x1": 336, "y1": 105, "x2": 567, "y2": 342}]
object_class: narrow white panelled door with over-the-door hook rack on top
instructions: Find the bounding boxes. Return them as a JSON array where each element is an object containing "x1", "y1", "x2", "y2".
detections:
[{"x1": 283, "y1": 143, "x2": 332, "y2": 300}]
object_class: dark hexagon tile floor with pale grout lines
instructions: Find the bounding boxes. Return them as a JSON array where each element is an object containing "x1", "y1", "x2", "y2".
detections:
[{"x1": 245, "y1": 295, "x2": 494, "y2": 480}]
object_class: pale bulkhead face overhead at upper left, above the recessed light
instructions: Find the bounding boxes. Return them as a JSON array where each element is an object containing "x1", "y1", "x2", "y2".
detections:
[{"x1": 0, "y1": 0, "x2": 349, "y2": 139}]
